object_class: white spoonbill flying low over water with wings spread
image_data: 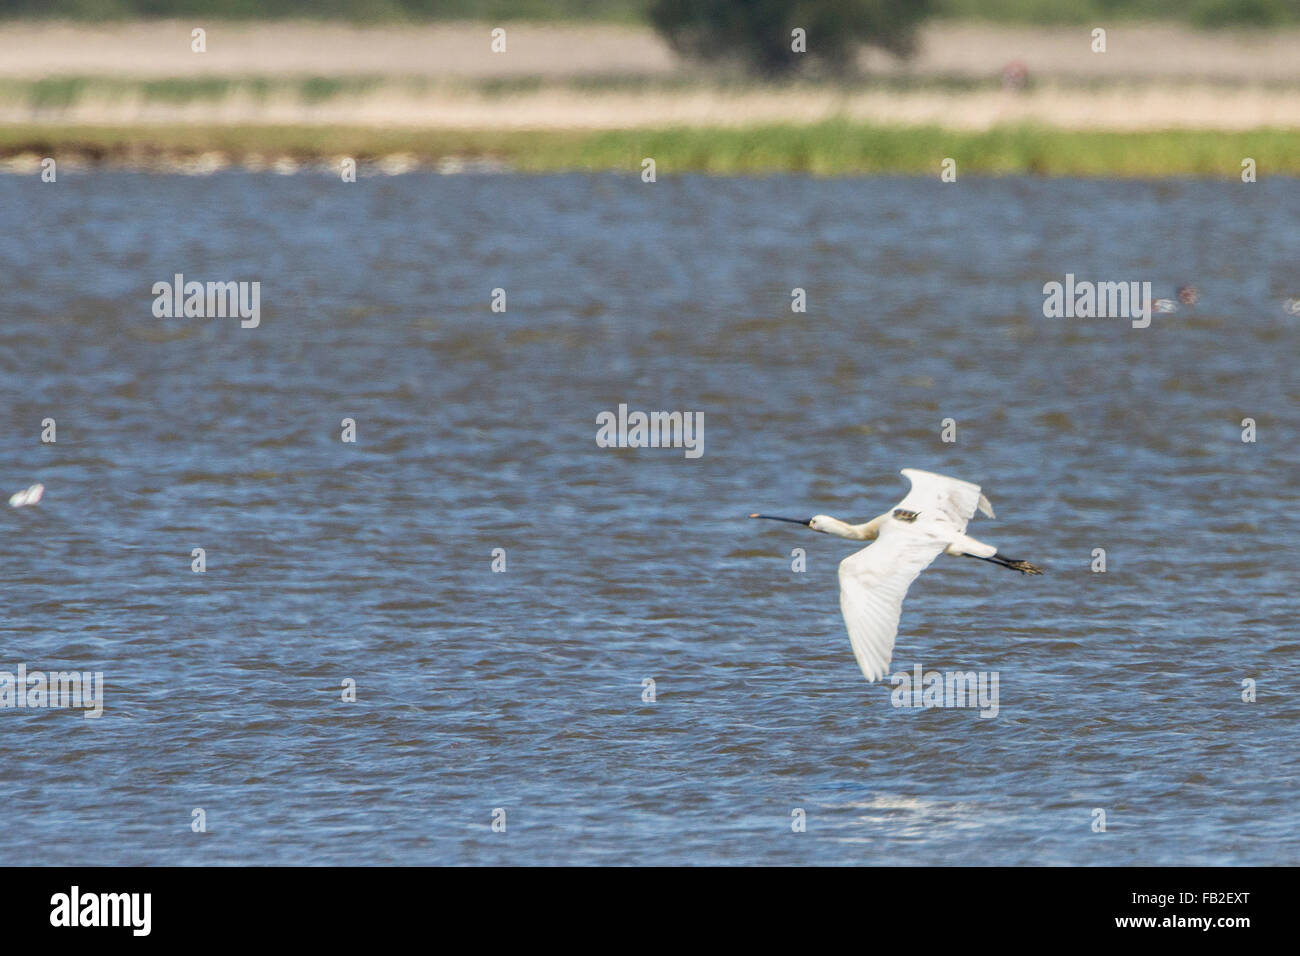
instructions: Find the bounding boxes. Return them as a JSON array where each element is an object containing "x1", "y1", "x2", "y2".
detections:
[{"x1": 750, "y1": 468, "x2": 1043, "y2": 680}]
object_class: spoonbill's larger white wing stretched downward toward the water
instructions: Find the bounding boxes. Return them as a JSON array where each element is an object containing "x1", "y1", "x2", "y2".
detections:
[{"x1": 840, "y1": 522, "x2": 951, "y2": 680}]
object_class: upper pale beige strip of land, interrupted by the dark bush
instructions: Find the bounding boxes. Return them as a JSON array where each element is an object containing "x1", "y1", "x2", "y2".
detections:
[{"x1": 0, "y1": 18, "x2": 1300, "y2": 83}]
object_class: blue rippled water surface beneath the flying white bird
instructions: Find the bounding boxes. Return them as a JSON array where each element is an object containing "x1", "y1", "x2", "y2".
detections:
[{"x1": 0, "y1": 172, "x2": 1300, "y2": 864}]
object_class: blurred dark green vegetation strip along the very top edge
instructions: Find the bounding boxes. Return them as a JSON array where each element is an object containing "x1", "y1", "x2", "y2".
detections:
[{"x1": 0, "y1": 0, "x2": 1300, "y2": 27}]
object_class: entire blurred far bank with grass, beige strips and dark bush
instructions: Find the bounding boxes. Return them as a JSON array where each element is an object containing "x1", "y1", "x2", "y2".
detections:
[{"x1": 0, "y1": 0, "x2": 1300, "y2": 179}]
